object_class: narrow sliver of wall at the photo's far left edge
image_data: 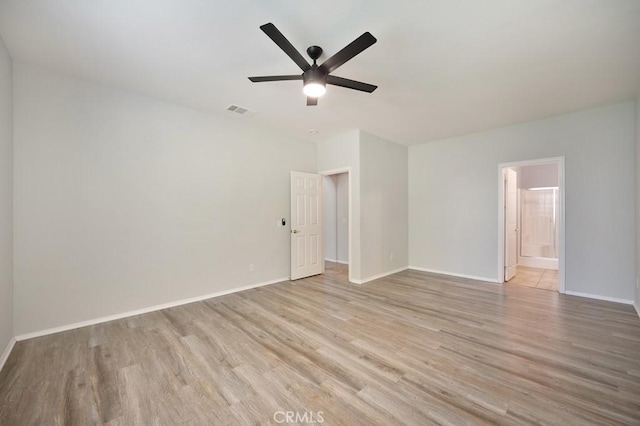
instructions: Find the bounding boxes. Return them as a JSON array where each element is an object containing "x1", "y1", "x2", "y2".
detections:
[{"x1": 0, "y1": 38, "x2": 14, "y2": 357}]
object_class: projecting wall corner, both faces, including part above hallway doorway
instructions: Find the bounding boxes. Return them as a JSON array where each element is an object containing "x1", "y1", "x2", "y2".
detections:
[{"x1": 318, "y1": 130, "x2": 409, "y2": 282}]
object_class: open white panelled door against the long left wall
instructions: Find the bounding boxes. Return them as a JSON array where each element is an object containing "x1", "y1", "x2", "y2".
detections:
[{"x1": 291, "y1": 172, "x2": 324, "y2": 280}]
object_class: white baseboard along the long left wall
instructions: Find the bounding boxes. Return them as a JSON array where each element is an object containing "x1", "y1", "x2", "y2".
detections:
[{"x1": 15, "y1": 277, "x2": 289, "y2": 341}]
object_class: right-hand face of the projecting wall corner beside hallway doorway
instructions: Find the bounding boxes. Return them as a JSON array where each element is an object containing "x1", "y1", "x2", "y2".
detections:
[{"x1": 360, "y1": 132, "x2": 409, "y2": 280}]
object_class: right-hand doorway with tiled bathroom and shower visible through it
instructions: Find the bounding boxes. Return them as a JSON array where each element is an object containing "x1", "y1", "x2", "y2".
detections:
[{"x1": 498, "y1": 157, "x2": 565, "y2": 293}]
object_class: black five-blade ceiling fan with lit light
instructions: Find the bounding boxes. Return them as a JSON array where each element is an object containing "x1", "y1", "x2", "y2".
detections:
[{"x1": 249, "y1": 22, "x2": 378, "y2": 106}]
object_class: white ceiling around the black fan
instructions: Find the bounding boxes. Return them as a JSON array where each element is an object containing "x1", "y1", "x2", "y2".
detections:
[{"x1": 0, "y1": 0, "x2": 640, "y2": 145}]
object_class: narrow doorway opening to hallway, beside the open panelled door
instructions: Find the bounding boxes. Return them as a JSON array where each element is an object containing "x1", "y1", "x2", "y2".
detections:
[{"x1": 321, "y1": 169, "x2": 351, "y2": 281}]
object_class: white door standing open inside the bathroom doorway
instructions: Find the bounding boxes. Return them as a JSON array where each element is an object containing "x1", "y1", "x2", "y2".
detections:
[{"x1": 504, "y1": 169, "x2": 518, "y2": 281}]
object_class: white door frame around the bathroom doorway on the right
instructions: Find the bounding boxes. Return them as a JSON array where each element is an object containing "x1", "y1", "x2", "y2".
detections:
[{"x1": 498, "y1": 157, "x2": 566, "y2": 293}]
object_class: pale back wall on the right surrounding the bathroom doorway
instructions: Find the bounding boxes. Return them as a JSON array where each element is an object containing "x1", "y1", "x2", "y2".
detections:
[{"x1": 409, "y1": 102, "x2": 636, "y2": 300}]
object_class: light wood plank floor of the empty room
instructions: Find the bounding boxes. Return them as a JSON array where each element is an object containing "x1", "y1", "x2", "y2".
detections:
[{"x1": 0, "y1": 265, "x2": 640, "y2": 426}]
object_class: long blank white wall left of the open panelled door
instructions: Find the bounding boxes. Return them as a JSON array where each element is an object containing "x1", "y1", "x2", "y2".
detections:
[{"x1": 14, "y1": 63, "x2": 316, "y2": 334}]
